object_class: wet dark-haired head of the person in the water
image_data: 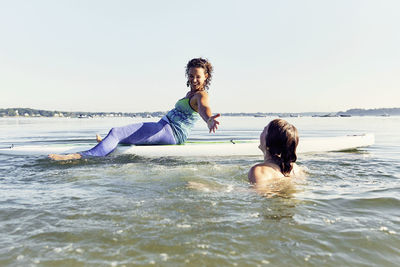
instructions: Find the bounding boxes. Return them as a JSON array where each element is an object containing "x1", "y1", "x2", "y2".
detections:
[{"x1": 260, "y1": 119, "x2": 299, "y2": 176}]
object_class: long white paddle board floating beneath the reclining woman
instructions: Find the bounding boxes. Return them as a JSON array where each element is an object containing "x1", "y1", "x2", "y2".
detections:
[{"x1": 0, "y1": 134, "x2": 375, "y2": 157}]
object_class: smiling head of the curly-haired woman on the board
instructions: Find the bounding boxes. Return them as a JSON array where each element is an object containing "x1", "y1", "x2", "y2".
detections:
[{"x1": 185, "y1": 58, "x2": 213, "y2": 90}]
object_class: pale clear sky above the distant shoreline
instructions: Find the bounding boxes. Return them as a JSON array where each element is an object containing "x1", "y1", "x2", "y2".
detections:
[{"x1": 0, "y1": 0, "x2": 400, "y2": 113}]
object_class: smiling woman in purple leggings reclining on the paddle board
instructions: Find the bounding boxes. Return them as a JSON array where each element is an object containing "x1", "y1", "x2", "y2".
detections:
[{"x1": 49, "y1": 58, "x2": 221, "y2": 160}]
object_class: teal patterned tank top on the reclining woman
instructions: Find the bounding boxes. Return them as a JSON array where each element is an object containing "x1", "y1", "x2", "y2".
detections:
[{"x1": 166, "y1": 98, "x2": 200, "y2": 144}]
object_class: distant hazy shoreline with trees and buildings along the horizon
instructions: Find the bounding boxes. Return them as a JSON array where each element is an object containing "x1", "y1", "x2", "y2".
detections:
[{"x1": 0, "y1": 108, "x2": 400, "y2": 118}]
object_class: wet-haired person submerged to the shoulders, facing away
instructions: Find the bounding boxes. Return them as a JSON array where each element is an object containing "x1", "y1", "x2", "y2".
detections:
[{"x1": 248, "y1": 119, "x2": 303, "y2": 192}]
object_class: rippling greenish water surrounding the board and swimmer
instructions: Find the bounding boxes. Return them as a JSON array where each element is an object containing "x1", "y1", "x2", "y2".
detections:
[{"x1": 0, "y1": 117, "x2": 400, "y2": 266}]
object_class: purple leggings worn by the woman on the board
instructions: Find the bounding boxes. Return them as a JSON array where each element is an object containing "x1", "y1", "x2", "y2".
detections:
[{"x1": 79, "y1": 119, "x2": 176, "y2": 157}]
